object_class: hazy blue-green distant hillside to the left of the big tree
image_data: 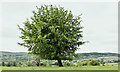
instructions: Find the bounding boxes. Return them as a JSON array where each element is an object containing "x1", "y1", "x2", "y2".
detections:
[{"x1": 0, "y1": 51, "x2": 33, "y2": 61}]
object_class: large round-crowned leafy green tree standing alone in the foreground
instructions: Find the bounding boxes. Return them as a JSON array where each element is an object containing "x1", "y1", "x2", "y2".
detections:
[{"x1": 18, "y1": 5, "x2": 85, "y2": 66}]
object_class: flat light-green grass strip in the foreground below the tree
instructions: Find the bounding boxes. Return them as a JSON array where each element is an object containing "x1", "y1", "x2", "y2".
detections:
[{"x1": 2, "y1": 66, "x2": 118, "y2": 70}]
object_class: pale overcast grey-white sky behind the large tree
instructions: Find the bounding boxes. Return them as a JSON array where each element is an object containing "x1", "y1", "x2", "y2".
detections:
[{"x1": 0, "y1": 2, "x2": 118, "y2": 53}]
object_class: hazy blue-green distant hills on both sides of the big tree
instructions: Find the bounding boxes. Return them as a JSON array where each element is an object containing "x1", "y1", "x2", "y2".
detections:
[{"x1": 0, "y1": 51, "x2": 120, "y2": 61}]
